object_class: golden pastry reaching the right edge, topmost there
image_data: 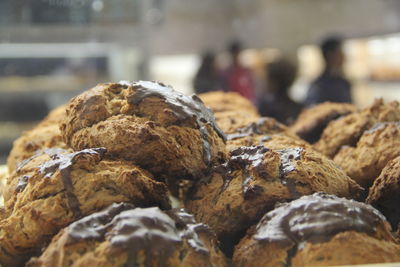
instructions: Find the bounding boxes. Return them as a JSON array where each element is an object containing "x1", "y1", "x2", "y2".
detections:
[{"x1": 314, "y1": 99, "x2": 400, "y2": 158}]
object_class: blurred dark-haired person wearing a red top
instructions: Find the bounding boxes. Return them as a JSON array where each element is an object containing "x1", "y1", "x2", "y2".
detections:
[{"x1": 222, "y1": 41, "x2": 256, "y2": 102}]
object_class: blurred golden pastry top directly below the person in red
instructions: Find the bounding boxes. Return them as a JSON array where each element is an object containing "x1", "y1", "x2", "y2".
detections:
[{"x1": 199, "y1": 91, "x2": 259, "y2": 116}]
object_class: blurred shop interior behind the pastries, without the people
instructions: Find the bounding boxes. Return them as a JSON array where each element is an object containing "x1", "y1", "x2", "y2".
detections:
[{"x1": 0, "y1": 0, "x2": 400, "y2": 164}]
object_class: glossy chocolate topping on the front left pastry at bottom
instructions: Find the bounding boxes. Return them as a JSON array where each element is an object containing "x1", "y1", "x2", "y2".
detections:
[{"x1": 67, "y1": 203, "x2": 212, "y2": 266}]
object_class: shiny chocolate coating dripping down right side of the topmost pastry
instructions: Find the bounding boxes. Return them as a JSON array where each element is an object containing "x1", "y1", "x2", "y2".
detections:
[{"x1": 120, "y1": 81, "x2": 226, "y2": 165}]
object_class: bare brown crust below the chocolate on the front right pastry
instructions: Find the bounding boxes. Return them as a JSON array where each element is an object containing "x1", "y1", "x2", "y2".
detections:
[{"x1": 233, "y1": 232, "x2": 400, "y2": 267}]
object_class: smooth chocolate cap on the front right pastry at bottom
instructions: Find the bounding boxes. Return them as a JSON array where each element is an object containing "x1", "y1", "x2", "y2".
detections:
[{"x1": 253, "y1": 193, "x2": 385, "y2": 245}]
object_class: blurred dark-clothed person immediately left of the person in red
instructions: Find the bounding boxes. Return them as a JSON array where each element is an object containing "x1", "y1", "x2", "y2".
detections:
[{"x1": 193, "y1": 51, "x2": 221, "y2": 94}]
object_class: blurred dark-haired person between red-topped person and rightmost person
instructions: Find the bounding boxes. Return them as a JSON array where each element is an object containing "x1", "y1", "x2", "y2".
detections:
[{"x1": 257, "y1": 59, "x2": 302, "y2": 124}]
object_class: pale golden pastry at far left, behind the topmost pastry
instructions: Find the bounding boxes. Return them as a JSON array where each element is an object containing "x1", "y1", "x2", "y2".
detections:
[{"x1": 7, "y1": 105, "x2": 67, "y2": 173}]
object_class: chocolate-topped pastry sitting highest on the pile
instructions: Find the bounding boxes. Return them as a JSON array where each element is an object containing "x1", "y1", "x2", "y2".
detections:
[{"x1": 60, "y1": 81, "x2": 225, "y2": 182}]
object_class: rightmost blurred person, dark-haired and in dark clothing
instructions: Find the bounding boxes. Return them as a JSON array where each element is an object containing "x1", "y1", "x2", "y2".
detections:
[{"x1": 304, "y1": 37, "x2": 352, "y2": 106}]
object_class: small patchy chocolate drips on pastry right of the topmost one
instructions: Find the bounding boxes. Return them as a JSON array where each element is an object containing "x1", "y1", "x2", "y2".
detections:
[{"x1": 216, "y1": 146, "x2": 269, "y2": 198}]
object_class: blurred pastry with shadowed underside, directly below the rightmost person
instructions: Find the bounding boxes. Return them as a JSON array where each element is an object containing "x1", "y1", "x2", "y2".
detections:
[{"x1": 290, "y1": 102, "x2": 357, "y2": 144}]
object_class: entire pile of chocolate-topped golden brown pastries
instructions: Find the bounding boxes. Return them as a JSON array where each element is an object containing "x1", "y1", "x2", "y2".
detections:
[{"x1": 0, "y1": 81, "x2": 400, "y2": 266}]
